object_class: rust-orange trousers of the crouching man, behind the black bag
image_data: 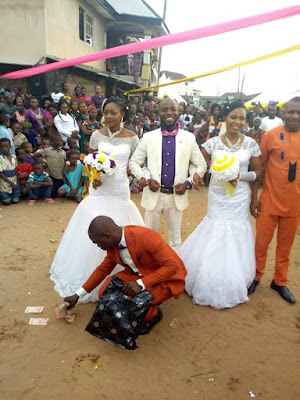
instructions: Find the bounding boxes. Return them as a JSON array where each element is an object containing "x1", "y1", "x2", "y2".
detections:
[{"x1": 99, "y1": 271, "x2": 173, "y2": 321}]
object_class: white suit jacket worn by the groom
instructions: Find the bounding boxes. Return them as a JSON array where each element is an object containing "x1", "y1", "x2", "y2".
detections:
[{"x1": 129, "y1": 128, "x2": 207, "y2": 211}]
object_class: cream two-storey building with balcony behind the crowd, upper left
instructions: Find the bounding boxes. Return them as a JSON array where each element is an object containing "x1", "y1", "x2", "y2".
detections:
[{"x1": 0, "y1": 0, "x2": 169, "y2": 96}]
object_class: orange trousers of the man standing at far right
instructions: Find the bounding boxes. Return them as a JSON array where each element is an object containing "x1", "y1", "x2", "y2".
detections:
[{"x1": 255, "y1": 212, "x2": 299, "y2": 286}]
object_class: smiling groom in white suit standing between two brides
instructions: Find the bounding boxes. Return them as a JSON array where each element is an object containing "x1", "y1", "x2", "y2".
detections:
[{"x1": 129, "y1": 98, "x2": 207, "y2": 252}]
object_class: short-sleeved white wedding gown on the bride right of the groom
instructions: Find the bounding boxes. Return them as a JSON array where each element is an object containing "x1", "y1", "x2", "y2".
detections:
[{"x1": 180, "y1": 136, "x2": 261, "y2": 309}]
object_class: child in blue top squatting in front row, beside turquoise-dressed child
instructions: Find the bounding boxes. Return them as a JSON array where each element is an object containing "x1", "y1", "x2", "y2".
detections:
[{"x1": 27, "y1": 160, "x2": 54, "y2": 206}]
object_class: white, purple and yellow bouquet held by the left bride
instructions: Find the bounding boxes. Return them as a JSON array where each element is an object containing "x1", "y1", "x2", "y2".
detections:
[{"x1": 83, "y1": 151, "x2": 117, "y2": 180}]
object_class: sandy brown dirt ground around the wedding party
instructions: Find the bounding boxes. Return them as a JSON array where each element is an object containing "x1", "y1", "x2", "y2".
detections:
[{"x1": 0, "y1": 188, "x2": 300, "y2": 400}]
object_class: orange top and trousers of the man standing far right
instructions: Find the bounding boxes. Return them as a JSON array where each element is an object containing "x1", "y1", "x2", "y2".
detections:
[{"x1": 255, "y1": 125, "x2": 300, "y2": 286}]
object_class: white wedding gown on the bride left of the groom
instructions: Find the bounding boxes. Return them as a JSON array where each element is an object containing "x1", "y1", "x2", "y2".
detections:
[{"x1": 50, "y1": 132, "x2": 144, "y2": 303}]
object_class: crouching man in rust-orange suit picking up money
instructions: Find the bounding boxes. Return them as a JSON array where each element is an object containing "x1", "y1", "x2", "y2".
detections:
[{"x1": 64, "y1": 216, "x2": 187, "y2": 334}]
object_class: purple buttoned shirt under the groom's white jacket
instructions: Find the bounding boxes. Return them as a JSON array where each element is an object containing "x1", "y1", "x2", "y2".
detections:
[{"x1": 161, "y1": 136, "x2": 176, "y2": 189}]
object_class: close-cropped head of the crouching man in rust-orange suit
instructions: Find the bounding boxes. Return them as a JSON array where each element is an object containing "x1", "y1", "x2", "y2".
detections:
[{"x1": 88, "y1": 215, "x2": 122, "y2": 250}]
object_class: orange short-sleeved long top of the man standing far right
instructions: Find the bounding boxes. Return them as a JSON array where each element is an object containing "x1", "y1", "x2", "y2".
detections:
[{"x1": 259, "y1": 125, "x2": 300, "y2": 217}]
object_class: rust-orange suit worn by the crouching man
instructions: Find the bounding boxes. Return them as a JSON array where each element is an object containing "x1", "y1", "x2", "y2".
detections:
[{"x1": 82, "y1": 225, "x2": 187, "y2": 321}]
